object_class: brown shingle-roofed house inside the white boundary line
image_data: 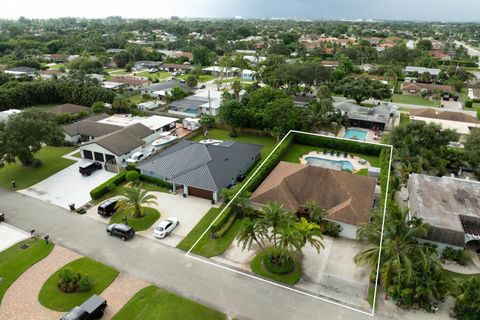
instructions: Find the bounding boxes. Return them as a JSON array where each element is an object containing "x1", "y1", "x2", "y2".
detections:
[{"x1": 250, "y1": 161, "x2": 377, "y2": 239}]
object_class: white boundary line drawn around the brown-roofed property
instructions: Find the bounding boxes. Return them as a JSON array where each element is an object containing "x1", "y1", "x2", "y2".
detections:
[{"x1": 185, "y1": 130, "x2": 393, "y2": 317}]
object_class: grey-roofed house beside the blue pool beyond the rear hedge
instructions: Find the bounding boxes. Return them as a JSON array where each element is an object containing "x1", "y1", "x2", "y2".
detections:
[{"x1": 333, "y1": 102, "x2": 399, "y2": 130}]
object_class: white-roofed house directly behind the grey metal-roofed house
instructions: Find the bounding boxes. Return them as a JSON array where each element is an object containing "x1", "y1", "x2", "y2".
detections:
[{"x1": 168, "y1": 91, "x2": 222, "y2": 117}]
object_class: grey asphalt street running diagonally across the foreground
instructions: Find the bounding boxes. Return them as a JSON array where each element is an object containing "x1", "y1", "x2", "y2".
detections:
[{"x1": 0, "y1": 188, "x2": 392, "y2": 320}]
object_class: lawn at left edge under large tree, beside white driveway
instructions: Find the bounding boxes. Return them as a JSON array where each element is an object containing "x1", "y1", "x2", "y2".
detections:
[{"x1": 0, "y1": 146, "x2": 75, "y2": 189}]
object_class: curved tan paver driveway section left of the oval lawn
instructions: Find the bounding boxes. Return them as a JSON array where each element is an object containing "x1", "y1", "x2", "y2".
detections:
[{"x1": 0, "y1": 246, "x2": 80, "y2": 320}]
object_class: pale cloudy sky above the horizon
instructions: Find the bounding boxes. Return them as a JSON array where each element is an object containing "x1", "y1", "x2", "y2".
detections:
[{"x1": 0, "y1": 0, "x2": 480, "y2": 21}]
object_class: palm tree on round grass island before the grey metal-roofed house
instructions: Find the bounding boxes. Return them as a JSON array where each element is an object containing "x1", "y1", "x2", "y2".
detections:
[{"x1": 117, "y1": 185, "x2": 157, "y2": 218}]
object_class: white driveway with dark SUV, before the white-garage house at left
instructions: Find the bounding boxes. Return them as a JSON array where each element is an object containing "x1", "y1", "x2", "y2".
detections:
[{"x1": 18, "y1": 160, "x2": 115, "y2": 209}]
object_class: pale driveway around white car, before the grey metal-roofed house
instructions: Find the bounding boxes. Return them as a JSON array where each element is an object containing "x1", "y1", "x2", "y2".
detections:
[{"x1": 86, "y1": 192, "x2": 212, "y2": 247}]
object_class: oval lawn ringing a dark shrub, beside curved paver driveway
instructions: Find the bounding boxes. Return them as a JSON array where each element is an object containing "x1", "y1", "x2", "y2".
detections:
[{"x1": 38, "y1": 257, "x2": 118, "y2": 311}]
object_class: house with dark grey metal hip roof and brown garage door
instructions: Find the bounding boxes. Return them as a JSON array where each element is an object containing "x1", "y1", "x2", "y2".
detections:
[{"x1": 138, "y1": 140, "x2": 262, "y2": 203}]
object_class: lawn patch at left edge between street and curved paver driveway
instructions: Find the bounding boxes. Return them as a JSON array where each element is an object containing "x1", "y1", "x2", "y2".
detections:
[{"x1": 0, "y1": 238, "x2": 54, "y2": 303}]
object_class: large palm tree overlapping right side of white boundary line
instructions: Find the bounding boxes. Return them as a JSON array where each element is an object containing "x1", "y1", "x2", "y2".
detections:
[{"x1": 353, "y1": 203, "x2": 429, "y2": 294}]
